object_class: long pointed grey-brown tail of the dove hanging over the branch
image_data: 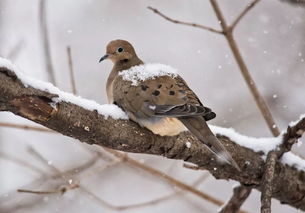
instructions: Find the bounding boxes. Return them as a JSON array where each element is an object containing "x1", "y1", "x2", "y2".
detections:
[{"x1": 179, "y1": 117, "x2": 240, "y2": 171}]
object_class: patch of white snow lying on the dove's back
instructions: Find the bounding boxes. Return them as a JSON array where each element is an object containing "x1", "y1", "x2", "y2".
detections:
[{"x1": 119, "y1": 63, "x2": 177, "y2": 86}]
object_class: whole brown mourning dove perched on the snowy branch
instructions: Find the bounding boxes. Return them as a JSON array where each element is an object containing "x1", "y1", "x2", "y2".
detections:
[{"x1": 100, "y1": 40, "x2": 239, "y2": 170}]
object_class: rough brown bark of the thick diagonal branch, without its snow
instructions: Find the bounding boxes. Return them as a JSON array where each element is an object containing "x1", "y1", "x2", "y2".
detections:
[{"x1": 0, "y1": 68, "x2": 305, "y2": 210}]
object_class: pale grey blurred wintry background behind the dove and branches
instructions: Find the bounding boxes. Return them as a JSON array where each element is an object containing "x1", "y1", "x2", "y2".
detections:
[{"x1": 0, "y1": 0, "x2": 305, "y2": 213}]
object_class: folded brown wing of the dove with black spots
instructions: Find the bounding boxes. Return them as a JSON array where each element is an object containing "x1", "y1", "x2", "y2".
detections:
[{"x1": 114, "y1": 76, "x2": 216, "y2": 120}]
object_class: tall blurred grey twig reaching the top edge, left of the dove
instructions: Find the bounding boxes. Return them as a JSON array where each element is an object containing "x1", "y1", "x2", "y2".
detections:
[{"x1": 39, "y1": 0, "x2": 56, "y2": 85}]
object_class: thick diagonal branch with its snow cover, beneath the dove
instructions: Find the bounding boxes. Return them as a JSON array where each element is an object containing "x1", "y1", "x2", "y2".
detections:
[{"x1": 0, "y1": 59, "x2": 305, "y2": 210}]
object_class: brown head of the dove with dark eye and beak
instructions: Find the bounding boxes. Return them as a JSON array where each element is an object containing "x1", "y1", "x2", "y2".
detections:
[{"x1": 99, "y1": 40, "x2": 138, "y2": 64}]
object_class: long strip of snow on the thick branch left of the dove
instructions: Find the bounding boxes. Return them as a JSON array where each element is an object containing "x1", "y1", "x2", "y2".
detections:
[{"x1": 0, "y1": 57, "x2": 128, "y2": 119}]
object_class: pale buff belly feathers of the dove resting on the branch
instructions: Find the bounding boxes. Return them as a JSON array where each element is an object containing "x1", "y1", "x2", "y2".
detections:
[{"x1": 137, "y1": 117, "x2": 187, "y2": 136}]
